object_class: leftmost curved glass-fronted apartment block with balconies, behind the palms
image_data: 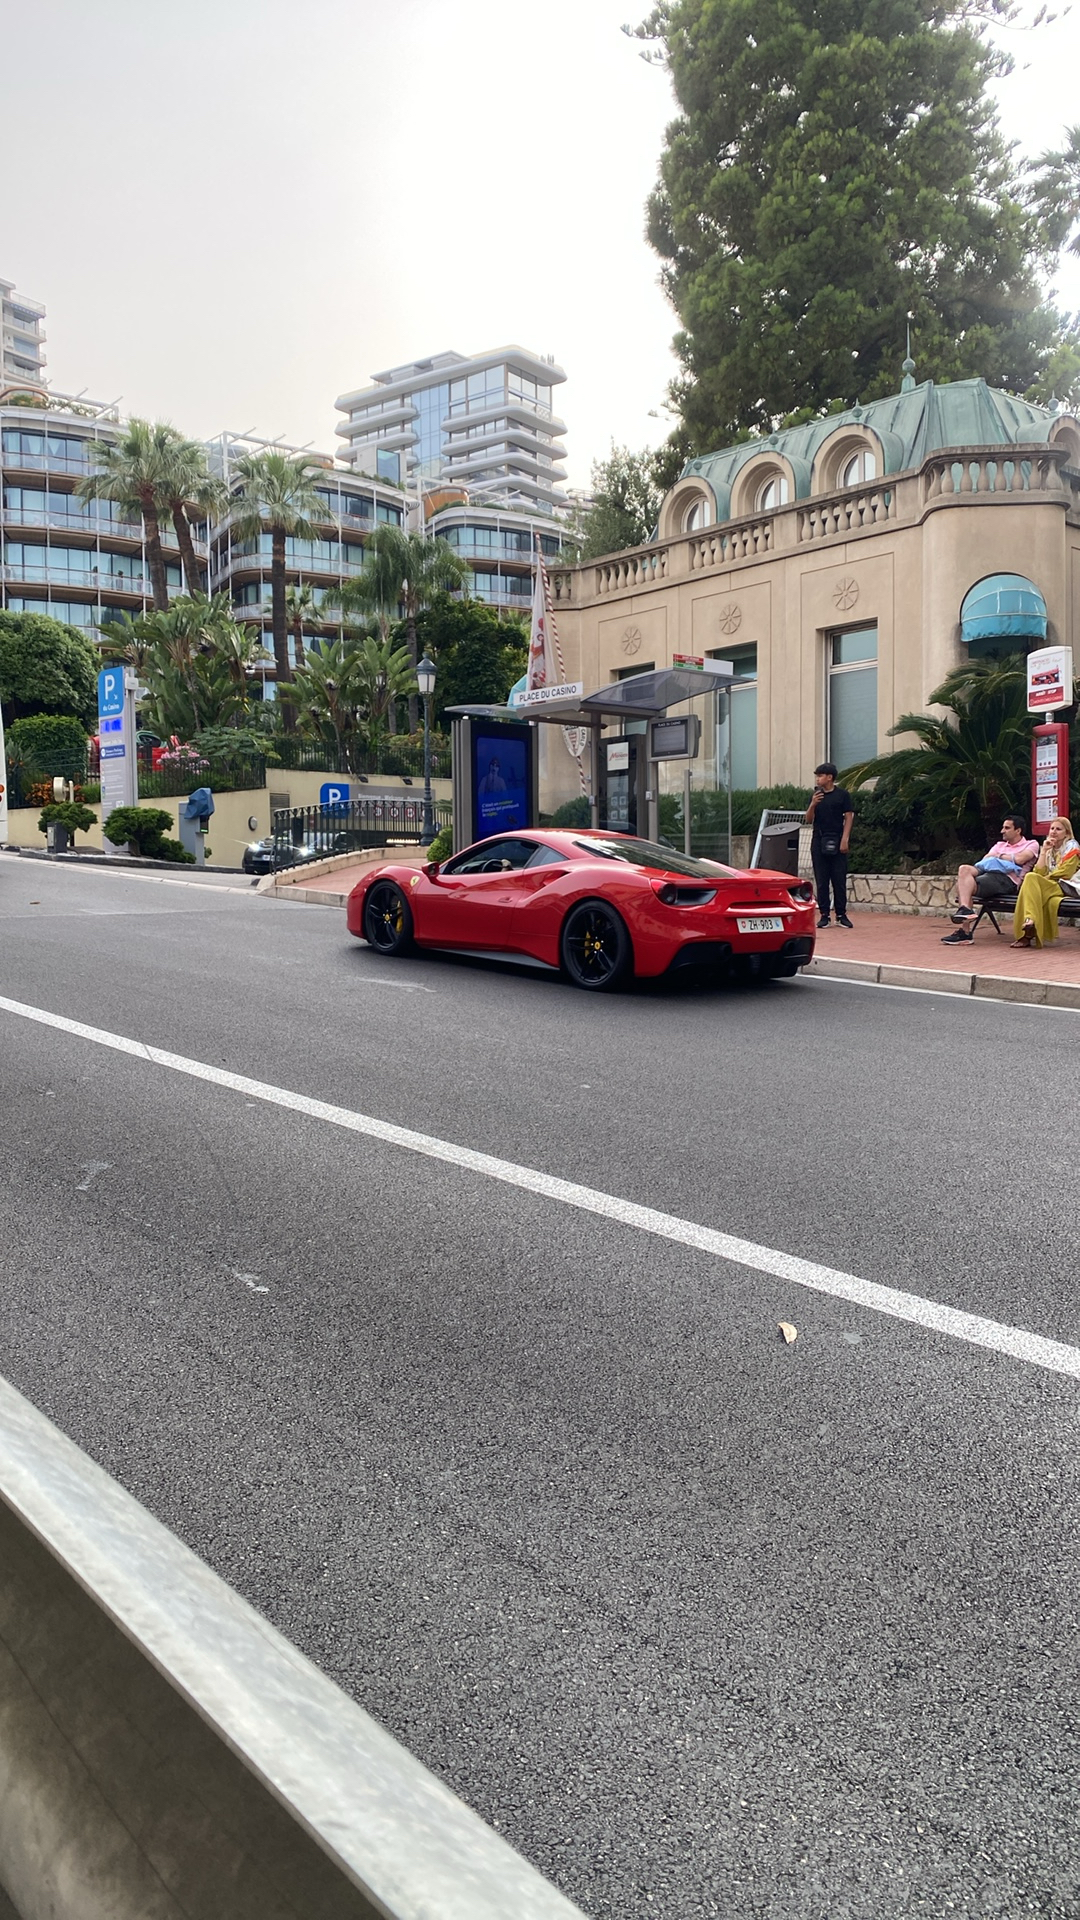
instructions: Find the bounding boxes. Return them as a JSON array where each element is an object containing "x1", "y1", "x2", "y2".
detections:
[{"x1": 0, "y1": 390, "x2": 187, "y2": 636}]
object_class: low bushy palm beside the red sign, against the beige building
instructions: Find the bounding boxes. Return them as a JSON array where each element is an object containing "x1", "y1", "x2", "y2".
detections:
[{"x1": 844, "y1": 655, "x2": 1032, "y2": 841}]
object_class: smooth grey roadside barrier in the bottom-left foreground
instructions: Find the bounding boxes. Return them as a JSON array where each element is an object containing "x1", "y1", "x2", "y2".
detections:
[{"x1": 0, "y1": 1380, "x2": 580, "y2": 1920}]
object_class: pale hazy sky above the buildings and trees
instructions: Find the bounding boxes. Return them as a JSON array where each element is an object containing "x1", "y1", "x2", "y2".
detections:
[{"x1": 0, "y1": 0, "x2": 1080, "y2": 486}]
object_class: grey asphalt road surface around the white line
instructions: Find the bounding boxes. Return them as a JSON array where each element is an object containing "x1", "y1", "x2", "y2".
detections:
[{"x1": 0, "y1": 858, "x2": 1080, "y2": 1920}]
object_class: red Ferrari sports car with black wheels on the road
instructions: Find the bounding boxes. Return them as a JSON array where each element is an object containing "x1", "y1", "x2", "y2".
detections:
[{"x1": 348, "y1": 828, "x2": 815, "y2": 993}]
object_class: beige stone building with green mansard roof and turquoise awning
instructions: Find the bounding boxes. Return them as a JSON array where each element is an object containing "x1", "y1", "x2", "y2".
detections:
[{"x1": 553, "y1": 374, "x2": 1080, "y2": 791}]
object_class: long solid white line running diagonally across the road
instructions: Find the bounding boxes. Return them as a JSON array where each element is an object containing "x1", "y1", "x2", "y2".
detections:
[{"x1": 0, "y1": 996, "x2": 1080, "y2": 1380}]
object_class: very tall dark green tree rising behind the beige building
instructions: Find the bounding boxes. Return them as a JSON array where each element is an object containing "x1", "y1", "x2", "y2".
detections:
[{"x1": 638, "y1": 0, "x2": 1061, "y2": 451}]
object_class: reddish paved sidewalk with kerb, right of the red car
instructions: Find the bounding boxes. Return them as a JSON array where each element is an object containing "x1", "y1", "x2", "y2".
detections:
[{"x1": 809, "y1": 908, "x2": 1080, "y2": 1008}]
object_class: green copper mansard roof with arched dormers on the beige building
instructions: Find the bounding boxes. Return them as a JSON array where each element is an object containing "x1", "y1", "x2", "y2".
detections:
[{"x1": 682, "y1": 380, "x2": 1057, "y2": 520}]
